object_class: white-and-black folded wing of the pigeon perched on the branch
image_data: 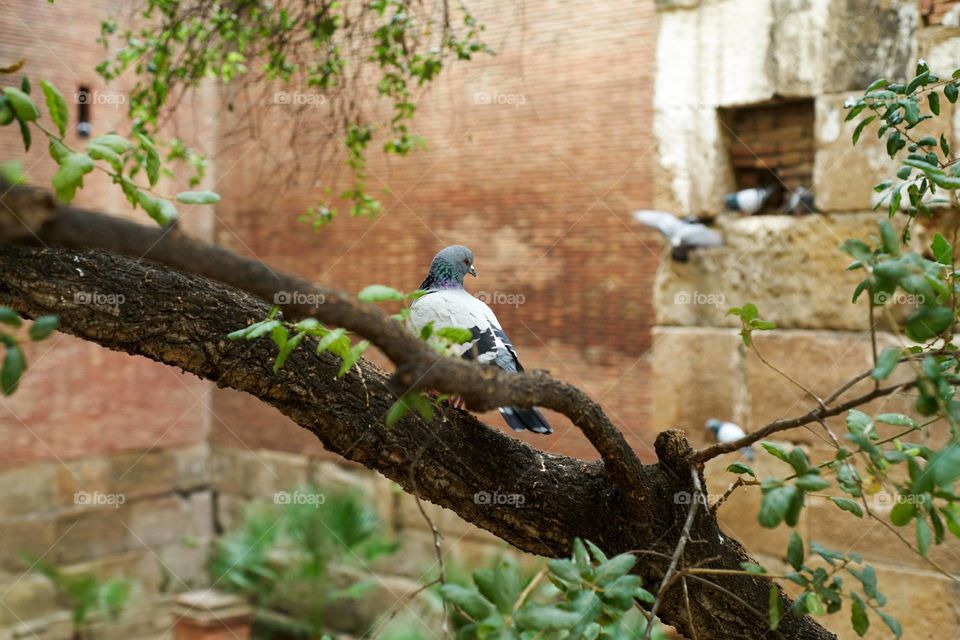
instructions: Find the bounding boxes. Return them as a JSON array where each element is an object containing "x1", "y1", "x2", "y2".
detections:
[{"x1": 409, "y1": 289, "x2": 506, "y2": 364}]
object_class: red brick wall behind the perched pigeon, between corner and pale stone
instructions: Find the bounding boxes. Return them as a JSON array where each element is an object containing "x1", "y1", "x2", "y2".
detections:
[{"x1": 212, "y1": 1, "x2": 660, "y2": 457}]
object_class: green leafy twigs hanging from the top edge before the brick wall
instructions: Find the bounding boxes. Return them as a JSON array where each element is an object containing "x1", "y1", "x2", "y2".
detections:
[{"x1": 97, "y1": 0, "x2": 490, "y2": 228}]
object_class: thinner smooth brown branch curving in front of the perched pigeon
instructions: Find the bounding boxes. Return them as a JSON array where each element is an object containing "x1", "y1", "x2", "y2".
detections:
[{"x1": 0, "y1": 183, "x2": 644, "y2": 500}]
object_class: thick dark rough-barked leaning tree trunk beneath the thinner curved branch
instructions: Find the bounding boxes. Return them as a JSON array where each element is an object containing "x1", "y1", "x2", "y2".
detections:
[{"x1": 0, "y1": 241, "x2": 835, "y2": 639}]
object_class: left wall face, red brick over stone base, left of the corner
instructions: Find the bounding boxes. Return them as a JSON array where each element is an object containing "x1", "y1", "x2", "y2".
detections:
[{"x1": 0, "y1": 0, "x2": 216, "y2": 640}]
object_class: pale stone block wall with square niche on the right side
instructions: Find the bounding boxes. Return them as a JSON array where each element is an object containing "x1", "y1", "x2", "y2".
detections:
[{"x1": 652, "y1": 0, "x2": 960, "y2": 638}]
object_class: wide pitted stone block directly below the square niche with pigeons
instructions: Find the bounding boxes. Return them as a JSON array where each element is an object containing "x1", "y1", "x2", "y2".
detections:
[{"x1": 655, "y1": 214, "x2": 908, "y2": 331}]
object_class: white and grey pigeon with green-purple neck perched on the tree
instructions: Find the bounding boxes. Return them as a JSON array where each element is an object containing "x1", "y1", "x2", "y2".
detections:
[{"x1": 408, "y1": 245, "x2": 553, "y2": 434}]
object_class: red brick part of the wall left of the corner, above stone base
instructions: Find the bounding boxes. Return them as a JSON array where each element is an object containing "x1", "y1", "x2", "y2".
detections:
[{"x1": 0, "y1": 0, "x2": 209, "y2": 468}]
